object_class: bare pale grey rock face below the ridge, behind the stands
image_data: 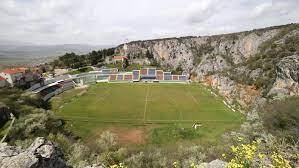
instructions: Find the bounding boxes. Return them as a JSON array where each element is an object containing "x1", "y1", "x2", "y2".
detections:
[{"x1": 116, "y1": 29, "x2": 278, "y2": 72}]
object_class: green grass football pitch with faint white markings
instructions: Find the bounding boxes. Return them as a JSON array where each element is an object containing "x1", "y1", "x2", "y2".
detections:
[{"x1": 51, "y1": 83, "x2": 242, "y2": 144}]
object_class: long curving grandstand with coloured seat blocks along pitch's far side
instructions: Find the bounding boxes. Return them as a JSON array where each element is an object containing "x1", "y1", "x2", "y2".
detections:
[{"x1": 28, "y1": 68, "x2": 188, "y2": 100}]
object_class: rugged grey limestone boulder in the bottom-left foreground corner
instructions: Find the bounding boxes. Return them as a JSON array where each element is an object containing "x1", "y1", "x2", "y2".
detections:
[{"x1": 0, "y1": 138, "x2": 66, "y2": 168}]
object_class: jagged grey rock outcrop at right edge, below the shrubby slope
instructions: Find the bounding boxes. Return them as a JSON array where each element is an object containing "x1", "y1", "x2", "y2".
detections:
[{"x1": 269, "y1": 55, "x2": 299, "y2": 95}]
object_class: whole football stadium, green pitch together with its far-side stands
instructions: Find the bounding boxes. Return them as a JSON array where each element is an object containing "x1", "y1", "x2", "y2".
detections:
[{"x1": 39, "y1": 68, "x2": 243, "y2": 145}]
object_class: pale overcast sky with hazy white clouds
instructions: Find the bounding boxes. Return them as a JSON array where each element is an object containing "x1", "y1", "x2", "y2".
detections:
[{"x1": 0, "y1": 0, "x2": 299, "y2": 45}]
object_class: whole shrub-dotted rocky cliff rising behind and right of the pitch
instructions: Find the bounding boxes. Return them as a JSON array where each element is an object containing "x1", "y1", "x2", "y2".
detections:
[{"x1": 116, "y1": 24, "x2": 299, "y2": 110}]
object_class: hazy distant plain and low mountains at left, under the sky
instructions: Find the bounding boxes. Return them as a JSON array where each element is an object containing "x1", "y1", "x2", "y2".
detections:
[{"x1": 0, "y1": 40, "x2": 113, "y2": 68}]
